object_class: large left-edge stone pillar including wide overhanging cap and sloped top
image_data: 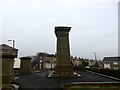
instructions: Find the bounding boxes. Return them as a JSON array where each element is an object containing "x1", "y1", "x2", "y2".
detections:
[{"x1": 0, "y1": 44, "x2": 18, "y2": 84}]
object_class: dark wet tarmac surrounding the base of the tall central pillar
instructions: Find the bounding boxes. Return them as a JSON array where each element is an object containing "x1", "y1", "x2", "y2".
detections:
[{"x1": 15, "y1": 71, "x2": 118, "y2": 90}]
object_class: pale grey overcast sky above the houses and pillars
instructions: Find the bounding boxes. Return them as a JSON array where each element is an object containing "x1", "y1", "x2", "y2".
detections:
[{"x1": 0, "y1": 0, "x2": 119, "y2": 64}]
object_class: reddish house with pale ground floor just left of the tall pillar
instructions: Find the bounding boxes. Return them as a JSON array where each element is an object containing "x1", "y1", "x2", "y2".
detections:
[{"x1": 31, "y1": 52, "x2": 56, "y2": 70}]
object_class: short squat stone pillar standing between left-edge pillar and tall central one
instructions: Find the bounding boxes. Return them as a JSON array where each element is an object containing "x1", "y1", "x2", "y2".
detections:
[{"x1": 20, "y1": 57, "x2": 32, "y2": 75}]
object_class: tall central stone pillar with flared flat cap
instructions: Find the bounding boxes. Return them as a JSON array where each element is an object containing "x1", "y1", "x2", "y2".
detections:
[{"x1": 55, "y1": 27, "x2": 73, "y2": 77}]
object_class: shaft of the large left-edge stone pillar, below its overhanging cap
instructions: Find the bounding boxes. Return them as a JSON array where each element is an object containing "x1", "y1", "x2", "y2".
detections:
[{"x1": 0, "y1": 56, "x2": 15, "y2": 84}]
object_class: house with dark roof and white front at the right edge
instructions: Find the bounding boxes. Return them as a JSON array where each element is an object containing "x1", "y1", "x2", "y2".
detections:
[{"x1": 103, "y1": 57, "x2": 120, "y2": 69}]
